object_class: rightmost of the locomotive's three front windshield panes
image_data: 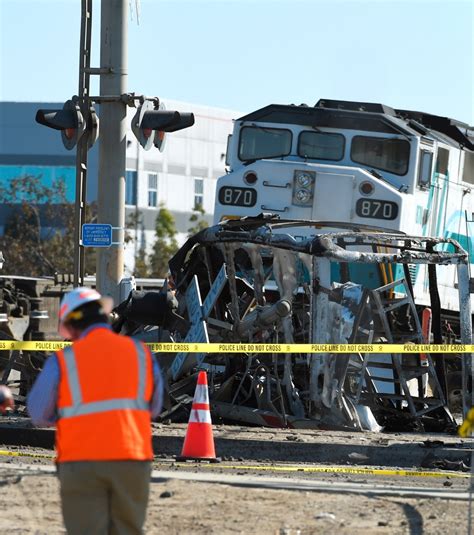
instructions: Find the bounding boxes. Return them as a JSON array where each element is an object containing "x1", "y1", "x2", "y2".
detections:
[{"x1": 351, "y1": 136, "x2": 410, "y2": 175}]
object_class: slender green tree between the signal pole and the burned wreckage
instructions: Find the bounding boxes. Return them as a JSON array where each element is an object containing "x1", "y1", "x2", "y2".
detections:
[{"x1": 150, "y1": 204, "x2": 178, "y2": 277}]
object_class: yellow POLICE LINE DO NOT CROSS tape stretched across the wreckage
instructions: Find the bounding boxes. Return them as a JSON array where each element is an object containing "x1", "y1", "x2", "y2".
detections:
[{"x1": 0, "y1": 340, "x2": 474, "y2": 354}]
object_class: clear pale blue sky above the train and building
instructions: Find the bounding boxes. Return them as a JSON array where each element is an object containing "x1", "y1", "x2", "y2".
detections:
[{"x1": 0, "y1": 0, "x2": 474, "y2": 125}]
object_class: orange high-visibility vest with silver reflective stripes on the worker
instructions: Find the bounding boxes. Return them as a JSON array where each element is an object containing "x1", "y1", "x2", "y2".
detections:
[{"x1": 56, "y1": 328, "x2": 153, "y2": 462}]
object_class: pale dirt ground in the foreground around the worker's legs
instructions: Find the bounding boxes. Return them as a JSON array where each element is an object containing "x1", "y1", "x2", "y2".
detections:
[{"x1": 0, "y1": 463, "x2": 468, "y2": 535}]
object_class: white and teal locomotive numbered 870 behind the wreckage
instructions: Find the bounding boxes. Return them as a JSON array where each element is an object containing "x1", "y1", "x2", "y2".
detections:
[{"x1": 215, "y1": 100, "x2": 474, "y2": 313}]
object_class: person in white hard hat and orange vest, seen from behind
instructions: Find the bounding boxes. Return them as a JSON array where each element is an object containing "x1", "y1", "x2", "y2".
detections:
[{"x1": 27, "y1": 288, "x2": 163, "y2": 535}]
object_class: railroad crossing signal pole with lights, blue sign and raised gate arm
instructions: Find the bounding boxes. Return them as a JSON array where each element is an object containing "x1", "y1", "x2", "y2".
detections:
[{"x1": 36, "y1": 0, "x2": 194, "y2": 304}]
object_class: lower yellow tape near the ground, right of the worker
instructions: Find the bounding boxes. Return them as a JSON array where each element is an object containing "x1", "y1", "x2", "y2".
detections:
[{"x1": 181, "y1": 463, "x2": 471, "y2": 479}]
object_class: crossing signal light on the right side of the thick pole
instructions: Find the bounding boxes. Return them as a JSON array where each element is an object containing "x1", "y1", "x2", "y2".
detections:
[{"x1": 132, "y1": 100, "x2": 194, "y2": 151}]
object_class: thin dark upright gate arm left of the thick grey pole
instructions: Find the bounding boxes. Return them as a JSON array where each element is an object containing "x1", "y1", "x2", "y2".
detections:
[{"x1": 73, "y1": 0, "x2": 92, "y2": 286}]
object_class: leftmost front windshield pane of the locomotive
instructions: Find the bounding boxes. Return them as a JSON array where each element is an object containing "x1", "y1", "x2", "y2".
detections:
[{"x1": 239, "y1": 126, "x2": 292, "y2": 161}]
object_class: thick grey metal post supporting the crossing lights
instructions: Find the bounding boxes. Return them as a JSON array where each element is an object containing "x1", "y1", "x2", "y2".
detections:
[{"x1": 97, "y1": 0, "x2": 128, "y2": 302}]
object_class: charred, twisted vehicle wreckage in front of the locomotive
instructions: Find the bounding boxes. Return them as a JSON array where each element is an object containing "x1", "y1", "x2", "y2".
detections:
[{"x1": 112, "y1": 216, "x2": 471, "y2": 431}]
